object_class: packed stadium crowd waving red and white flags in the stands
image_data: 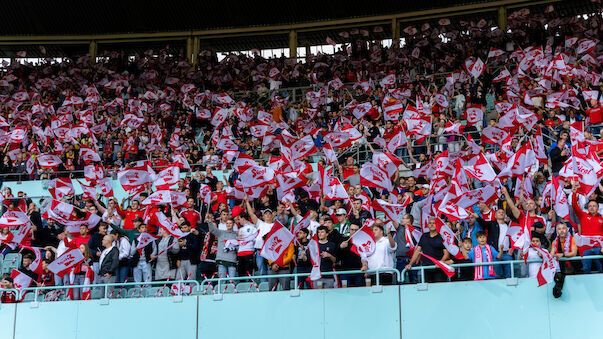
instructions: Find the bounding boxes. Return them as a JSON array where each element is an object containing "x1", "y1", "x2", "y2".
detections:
[{"x1": 0, "y1": 5, "x2": 603, "y2": 302}]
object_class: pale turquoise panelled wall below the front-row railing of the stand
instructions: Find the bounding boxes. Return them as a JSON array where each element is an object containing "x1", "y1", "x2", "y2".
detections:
[{"x1": 0, "y1": 274, "x2": 603, "y2": 339}]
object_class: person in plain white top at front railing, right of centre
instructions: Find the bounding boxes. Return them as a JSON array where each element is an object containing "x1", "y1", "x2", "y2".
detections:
[{"x1": 367, "y1": 220, "x2": 397, "y2": 285}]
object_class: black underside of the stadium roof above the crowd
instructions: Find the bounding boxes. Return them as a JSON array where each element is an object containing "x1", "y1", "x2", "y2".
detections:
[{"x1": 0, "y1": 0, "x2": 596, "y2": 36}]
